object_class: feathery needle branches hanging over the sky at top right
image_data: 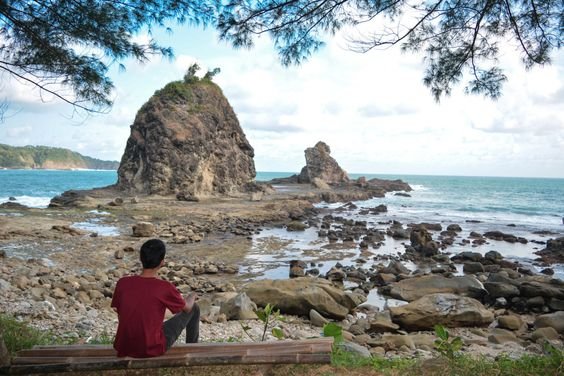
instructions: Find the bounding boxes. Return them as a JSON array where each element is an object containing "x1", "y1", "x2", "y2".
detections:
[{"x1": 218, "y1": 0, "x2": 564, "y2": 100}]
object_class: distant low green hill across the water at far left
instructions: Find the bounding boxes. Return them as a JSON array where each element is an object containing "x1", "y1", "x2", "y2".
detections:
[{"x1": 0, "y1": 144, "x2": 119, "y2": 170}]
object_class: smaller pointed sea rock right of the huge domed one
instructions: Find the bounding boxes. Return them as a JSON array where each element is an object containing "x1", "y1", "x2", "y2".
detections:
[{"x1": 298, "y1": 141, "x2": 349, "y2": 184}]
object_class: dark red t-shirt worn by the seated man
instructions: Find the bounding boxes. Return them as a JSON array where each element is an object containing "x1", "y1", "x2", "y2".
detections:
[{"x1": 112, "y1": 276, "x2": 186, "y2": 358}]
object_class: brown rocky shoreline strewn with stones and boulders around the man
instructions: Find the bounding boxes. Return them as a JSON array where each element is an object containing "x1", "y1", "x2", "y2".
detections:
[{"x1": 0, "y1": 182, "x2": 564, "y2": 357}]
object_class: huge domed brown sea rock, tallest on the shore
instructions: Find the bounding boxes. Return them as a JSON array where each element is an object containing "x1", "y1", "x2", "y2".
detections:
[{"x1": 117, "y1": 79, "x2": 256, "y2": 196}]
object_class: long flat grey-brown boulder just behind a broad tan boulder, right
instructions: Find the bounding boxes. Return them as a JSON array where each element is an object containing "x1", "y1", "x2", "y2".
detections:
[{"x1": 380, "y1": 275, "x2": 486, "y2": 302}]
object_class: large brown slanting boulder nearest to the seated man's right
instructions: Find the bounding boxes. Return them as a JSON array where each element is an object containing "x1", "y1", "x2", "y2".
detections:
[{"x1": 243, "y1": 277, "x2": 357, "y2": 320}]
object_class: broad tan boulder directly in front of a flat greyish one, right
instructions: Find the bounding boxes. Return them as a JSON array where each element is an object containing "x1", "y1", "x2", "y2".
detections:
[{"x1": 390, "y1": 294, "x2": 494, "y2": 330}]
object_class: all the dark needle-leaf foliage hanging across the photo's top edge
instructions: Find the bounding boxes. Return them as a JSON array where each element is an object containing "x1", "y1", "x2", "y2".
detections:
[{"x1": 0, "y1": 0, "x2": 564, "y2": 115}]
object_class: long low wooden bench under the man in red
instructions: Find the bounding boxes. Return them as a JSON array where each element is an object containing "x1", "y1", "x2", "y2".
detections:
[{"x1": 0, "y1": 337, "x2": 333, "y2": 375}]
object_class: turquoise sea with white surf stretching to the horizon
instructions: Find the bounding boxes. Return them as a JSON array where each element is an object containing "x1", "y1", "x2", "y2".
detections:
[{"x1": 0, "y1": 170, "x2": 564, "y2": 232}]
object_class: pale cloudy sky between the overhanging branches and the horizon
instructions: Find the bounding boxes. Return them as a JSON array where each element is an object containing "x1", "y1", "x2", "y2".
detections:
[{"x1": 0, "y1": 27, "x2": 564, "y2": 177}]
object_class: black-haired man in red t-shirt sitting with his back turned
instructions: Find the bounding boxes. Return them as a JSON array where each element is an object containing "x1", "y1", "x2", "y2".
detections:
[{"x1": 111, "y1": 239, "x2": 200, "y2": 358}]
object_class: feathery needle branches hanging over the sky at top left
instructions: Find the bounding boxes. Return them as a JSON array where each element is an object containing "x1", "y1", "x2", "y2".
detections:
[{"x1": 0, "y1": 0, "x2": 213, "y2": 111}]
